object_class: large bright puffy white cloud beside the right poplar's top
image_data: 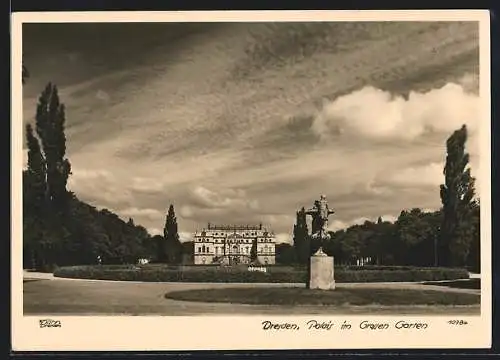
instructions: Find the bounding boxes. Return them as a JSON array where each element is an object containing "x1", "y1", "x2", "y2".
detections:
[{"x1": 312, "y1": 80, "x2": 480, "y2": 140}]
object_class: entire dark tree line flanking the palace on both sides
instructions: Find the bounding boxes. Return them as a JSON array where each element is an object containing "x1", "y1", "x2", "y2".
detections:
[{"x1": 22, "y1": 77, "x2": 480, "y2": 270}]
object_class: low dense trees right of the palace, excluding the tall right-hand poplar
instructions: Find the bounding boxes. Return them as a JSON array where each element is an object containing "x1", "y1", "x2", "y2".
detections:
[{"x1": 290, "y1": 203, "x2": 480, "y2": 271}]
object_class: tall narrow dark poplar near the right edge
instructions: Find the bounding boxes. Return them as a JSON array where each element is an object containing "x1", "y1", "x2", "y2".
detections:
[{"x1": 438, "y1": 125, "x2": 475, "y2": 266}]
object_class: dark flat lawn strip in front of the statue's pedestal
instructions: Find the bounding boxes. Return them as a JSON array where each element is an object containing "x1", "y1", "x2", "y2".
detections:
[{"x1": 165, "y1": 288, "x2": 480, "y2": 306}]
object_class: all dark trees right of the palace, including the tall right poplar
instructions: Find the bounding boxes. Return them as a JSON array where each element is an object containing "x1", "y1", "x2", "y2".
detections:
[{"x1": 288, "y1": 125, "x2": 480, "y2": 271}]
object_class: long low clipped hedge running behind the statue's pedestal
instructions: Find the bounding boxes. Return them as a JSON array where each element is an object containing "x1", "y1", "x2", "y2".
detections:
[{"x1": 54, "y1": 265, "x2": 469, "y2": 283}]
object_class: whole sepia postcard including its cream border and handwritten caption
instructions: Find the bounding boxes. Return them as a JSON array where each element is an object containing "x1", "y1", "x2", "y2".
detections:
[{"x1": 12, "y1": 11, "x2": 491, "y2": 348}]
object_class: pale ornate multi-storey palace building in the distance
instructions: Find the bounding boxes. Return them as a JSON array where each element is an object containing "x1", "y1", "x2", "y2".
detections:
[{"x1": 193, "y1": 223, "x2": 275, "y2": 265}]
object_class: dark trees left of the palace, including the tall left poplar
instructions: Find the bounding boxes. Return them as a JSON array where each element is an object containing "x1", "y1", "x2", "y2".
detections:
[{"x1": 23, "y1": 81, "x2": 183, "y2": 270}]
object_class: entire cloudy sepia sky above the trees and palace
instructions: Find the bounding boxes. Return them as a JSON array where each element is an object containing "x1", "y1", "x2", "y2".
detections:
[{"x1": 23, "y1": 22, "x2": 480, "y2": 242}]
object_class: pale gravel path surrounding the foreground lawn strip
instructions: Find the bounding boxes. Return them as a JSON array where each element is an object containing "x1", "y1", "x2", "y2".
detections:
[{"x1": 23, "y1": 273, "x2": 480, "y2": 316}]
